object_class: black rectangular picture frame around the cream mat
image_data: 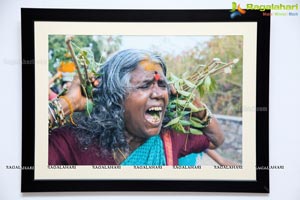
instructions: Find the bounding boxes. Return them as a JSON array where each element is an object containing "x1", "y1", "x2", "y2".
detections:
[{"x1": 21, "y1": 8, "x2": 270, "y2": 193}]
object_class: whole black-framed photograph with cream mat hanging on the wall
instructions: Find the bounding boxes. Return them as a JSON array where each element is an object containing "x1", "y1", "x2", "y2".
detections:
[{"x1": 21, "y1": 8, "x2": 270, "y2": 193}]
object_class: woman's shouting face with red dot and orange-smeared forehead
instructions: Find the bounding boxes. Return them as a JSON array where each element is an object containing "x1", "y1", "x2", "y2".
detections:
[{"x1": 124, "y1": 61, "x2": 169, "y2": 146}]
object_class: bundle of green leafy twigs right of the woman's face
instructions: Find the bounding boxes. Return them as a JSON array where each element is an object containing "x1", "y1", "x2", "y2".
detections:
[{"x1": 165, "y1": 58, "x2": 238, "y2": 135}]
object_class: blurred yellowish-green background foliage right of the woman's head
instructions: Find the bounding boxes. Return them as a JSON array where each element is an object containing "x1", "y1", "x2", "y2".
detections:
[{"x1": 161, "y1": 35, "x2": 243, "y2": 116}]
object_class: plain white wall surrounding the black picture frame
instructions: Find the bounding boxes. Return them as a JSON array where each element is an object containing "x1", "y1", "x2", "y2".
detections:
[{"x1": 0, "y1": 0, "x2": 300, "y2": 200}]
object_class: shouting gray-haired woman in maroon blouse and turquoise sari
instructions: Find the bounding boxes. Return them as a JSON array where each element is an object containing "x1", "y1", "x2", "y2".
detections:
[{"x1": 49, "y1": 49, "x2": 224, "y2": 165}]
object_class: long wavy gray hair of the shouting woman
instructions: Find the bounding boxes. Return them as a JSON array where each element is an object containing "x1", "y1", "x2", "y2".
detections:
[{"x1": 74, "y1": 49, "x2": 166, "y2": 152}]
